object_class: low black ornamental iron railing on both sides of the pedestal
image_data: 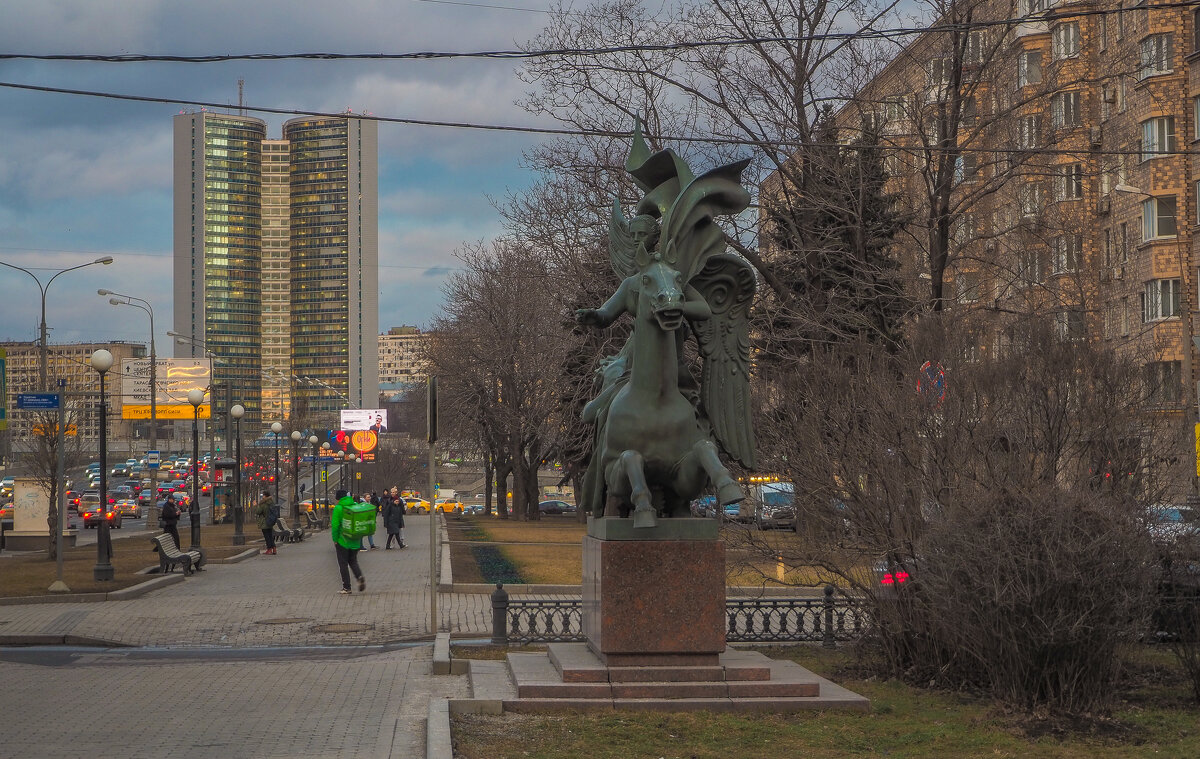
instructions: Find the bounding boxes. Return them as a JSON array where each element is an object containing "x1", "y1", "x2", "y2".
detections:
[{"x1": 492, "y1": 585, "x2": 866, "y2": 646}]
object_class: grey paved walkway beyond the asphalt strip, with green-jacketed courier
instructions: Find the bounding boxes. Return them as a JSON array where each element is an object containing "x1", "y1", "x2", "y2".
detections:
[{"x1": 0, "y1": 515, "x2": 492, "y2": 647}]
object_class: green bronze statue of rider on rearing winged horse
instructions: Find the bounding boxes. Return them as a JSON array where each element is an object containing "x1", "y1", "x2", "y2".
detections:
[{"x1": 576, "y1": 120, "x2": 755, "y2": 527}]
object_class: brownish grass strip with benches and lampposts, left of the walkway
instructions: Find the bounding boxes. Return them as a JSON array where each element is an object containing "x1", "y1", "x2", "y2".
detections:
[{"x1": 0, "y1": 525, "x2": 255, "y2": 597}]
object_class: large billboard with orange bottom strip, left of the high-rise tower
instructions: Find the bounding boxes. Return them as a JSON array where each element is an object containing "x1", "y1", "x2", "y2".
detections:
[{"x1": 121, "y1": 358, "x2": 212, "y2": 419}]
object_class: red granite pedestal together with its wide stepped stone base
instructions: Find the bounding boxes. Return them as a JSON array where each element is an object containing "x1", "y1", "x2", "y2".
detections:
[{"x1": 451, "y1": 519, "x2": 870, "y2": 712}]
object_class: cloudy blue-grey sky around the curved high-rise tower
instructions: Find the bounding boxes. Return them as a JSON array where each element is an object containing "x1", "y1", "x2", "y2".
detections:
[{"x1": 0, "y1": 0, "x2": 553, "y2": 354}]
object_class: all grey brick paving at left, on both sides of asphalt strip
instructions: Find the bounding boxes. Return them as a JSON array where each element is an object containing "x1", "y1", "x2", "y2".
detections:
[{"x1": 0, "y1": 516, "x2": 491, "y2": 758}]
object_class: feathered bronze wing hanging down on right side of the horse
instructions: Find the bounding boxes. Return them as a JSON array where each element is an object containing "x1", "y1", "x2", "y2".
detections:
[{"x1": 691, "y1": 253, "x2": 757, "y2": 470}]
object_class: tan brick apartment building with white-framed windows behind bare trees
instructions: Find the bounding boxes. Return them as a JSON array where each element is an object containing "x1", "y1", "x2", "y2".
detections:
[{"x1": 811, "y1": 0, "x2": 1200, "y2": 418}]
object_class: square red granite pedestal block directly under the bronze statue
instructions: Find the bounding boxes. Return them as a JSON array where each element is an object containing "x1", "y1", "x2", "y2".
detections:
[{"x1": 583, "y1": 528, "x2": 725, "y2": 667}]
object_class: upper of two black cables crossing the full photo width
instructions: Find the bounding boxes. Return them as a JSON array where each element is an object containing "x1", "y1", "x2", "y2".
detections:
[{"x1": 0, "y1": 0, "x2": 1200, "y2": 64}]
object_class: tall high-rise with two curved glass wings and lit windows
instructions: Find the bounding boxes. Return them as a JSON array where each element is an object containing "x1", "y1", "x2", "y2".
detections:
[{"x1": 174, "y1": 112, "x2": 379, "y2": 428}]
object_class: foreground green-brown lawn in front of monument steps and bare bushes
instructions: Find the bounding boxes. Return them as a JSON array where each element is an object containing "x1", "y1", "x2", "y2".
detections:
[{"x1": 452, "y1": 646, "x2": 1200, "y2": 759}]
